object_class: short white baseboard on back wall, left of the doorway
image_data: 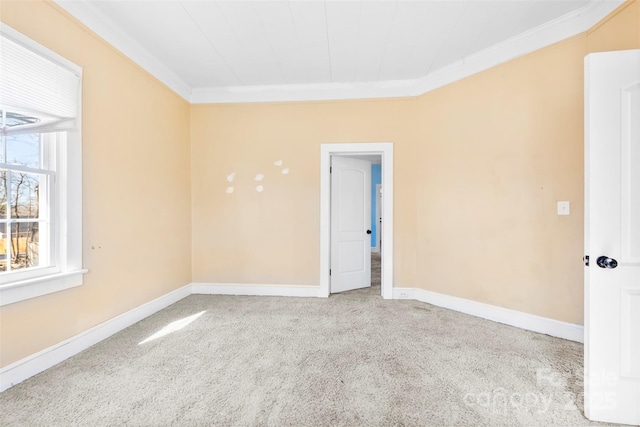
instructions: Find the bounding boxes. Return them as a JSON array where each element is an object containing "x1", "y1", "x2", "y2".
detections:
[{"x1": 191, "y1": 283, "x2": 318, "y2": 297}]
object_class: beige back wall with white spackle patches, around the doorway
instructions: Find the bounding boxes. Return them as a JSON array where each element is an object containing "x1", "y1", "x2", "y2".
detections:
[{"x1": 191, "y1": 99, "x2": 416, "y2": 285}]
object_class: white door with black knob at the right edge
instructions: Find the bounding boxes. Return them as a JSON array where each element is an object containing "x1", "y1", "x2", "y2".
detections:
[{"x1": 584, "y1": 50, "x2": 640, "y2": 425}]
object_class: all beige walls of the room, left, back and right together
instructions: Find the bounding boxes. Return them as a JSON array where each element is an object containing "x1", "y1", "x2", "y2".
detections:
[{"x1": 0, "y1": 0, "x2": 640, "y2": 366}]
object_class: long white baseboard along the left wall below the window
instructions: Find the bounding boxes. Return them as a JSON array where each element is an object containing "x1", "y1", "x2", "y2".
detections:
[{"x1": 0, "y1": 285, "x2": 191, "y2": 392}]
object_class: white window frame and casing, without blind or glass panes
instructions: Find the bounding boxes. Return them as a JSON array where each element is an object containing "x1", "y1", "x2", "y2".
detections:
[{"x1": 0, "y1": 25, "x2": 88, "y2": 306}]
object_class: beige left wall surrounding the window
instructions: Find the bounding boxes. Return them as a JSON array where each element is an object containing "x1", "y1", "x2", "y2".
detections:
[{"x1": 0, "y1": 0, "x2": 191, "y2": 366}]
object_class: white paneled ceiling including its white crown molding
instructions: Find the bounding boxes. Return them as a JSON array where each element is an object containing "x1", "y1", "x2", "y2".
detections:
[{"x1": 58, "y1": 0, "x2": 621, "y2": 102}]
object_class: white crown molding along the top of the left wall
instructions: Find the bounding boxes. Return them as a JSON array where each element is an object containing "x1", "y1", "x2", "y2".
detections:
[{"x1": 55, "y1": 0, "x2": 191, "y2": 101}]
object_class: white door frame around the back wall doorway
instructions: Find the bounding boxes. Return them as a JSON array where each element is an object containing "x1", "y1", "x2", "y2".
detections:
[{"x1": 318, "y1": 142, "x2": 393, "y2": 299}]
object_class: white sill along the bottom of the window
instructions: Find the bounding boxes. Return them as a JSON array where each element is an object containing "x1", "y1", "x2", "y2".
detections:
[{"x1": 0, "y1": 269, "x2": 88, "y2": 306}]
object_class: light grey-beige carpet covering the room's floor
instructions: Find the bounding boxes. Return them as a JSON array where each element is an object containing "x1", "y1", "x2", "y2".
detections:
[{"x1": 0, "y1": 256, "x2": 612, "y2": 426}]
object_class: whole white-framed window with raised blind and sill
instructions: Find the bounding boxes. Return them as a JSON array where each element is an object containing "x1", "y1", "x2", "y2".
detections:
[{"x1": 0, "y1": 25, "x2": 86, "y2": 305}]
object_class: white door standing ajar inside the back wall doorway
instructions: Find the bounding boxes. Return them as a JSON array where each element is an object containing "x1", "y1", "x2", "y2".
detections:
[{"x1": 330, "y1": 156, "x2": 371, "y2": 293}]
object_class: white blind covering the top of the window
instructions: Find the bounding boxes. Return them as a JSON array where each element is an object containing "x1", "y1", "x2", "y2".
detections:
[{"x1": 0, "y1": 25, "x2": 81, "y2": 134}]
